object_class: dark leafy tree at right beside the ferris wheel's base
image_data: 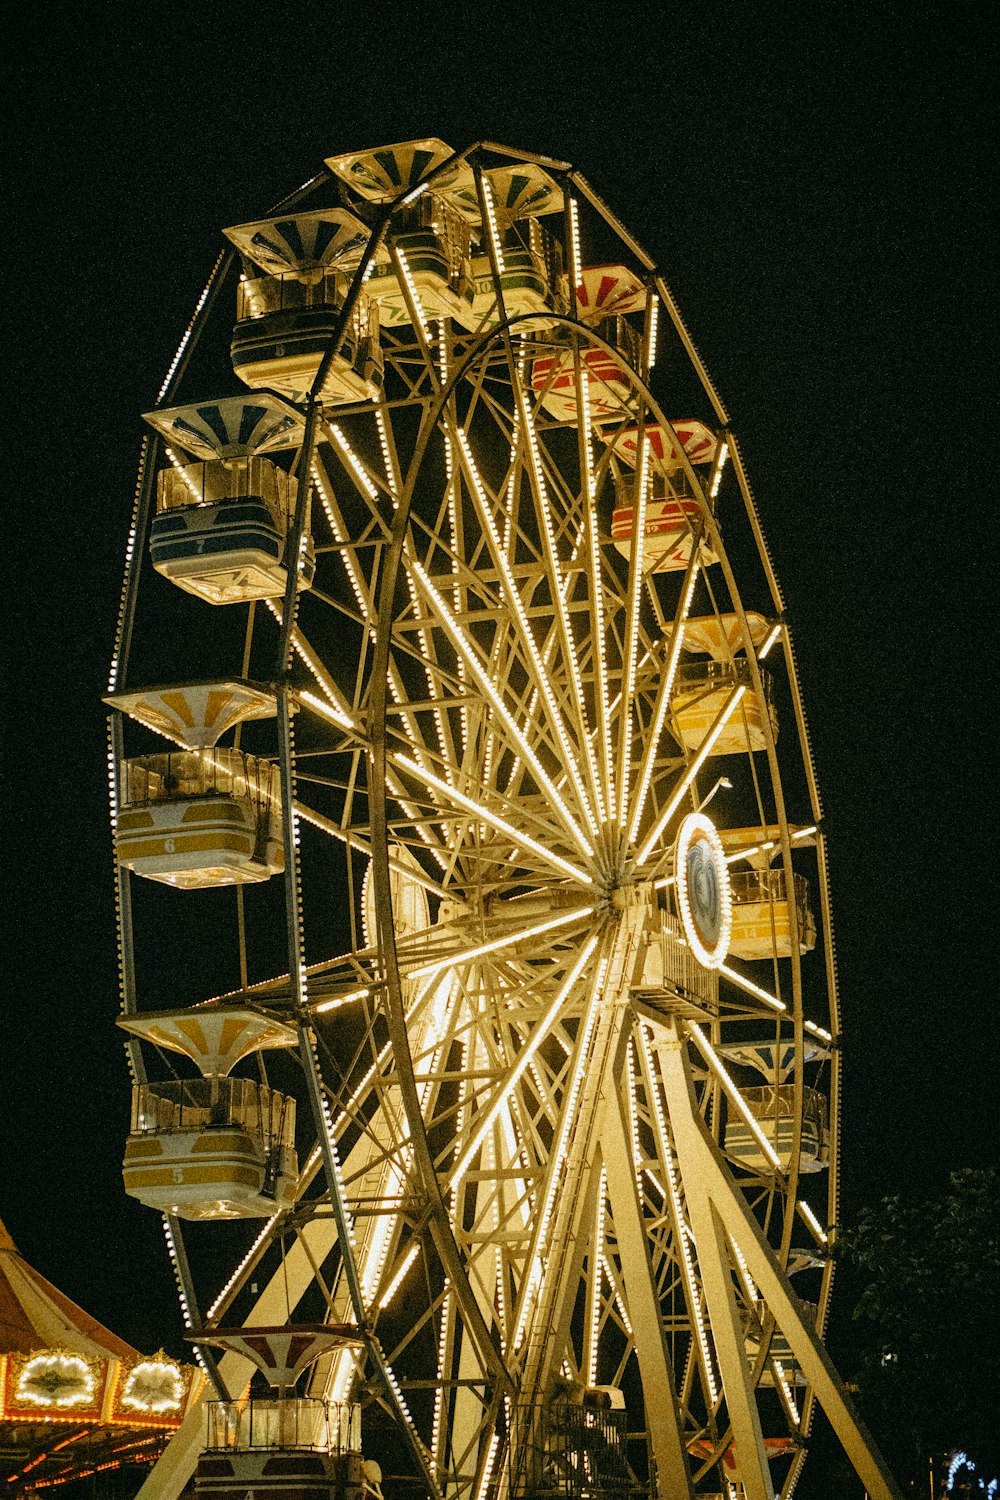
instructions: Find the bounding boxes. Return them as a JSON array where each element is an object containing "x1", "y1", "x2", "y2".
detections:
[{"x1": 841, "y1": 1169, "x2": 1000, "y2": 1481}]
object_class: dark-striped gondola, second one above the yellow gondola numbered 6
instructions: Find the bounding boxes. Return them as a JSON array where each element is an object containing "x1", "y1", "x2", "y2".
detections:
[{"x1": 225, "y1": 209, "x2": 382, "y2": 407}]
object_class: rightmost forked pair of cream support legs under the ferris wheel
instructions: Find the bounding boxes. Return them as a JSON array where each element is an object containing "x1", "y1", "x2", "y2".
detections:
[{"x1": 657, "y1": 1023, "x2": 901, "y2": 1500}]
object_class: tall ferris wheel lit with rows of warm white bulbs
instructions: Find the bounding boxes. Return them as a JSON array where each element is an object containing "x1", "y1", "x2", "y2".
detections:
[{"x1": 106, "y1": 140, "x2": 895, "y2": 1500}]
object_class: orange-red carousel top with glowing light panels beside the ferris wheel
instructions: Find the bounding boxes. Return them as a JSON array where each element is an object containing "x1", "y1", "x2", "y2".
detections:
[{"x1": 0, "y1": 1223, "x2": 202, "y2": 1494}]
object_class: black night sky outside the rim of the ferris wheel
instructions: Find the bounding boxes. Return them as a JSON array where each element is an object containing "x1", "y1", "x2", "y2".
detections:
[{"x1": 0, "y1": 0, "x2": 999, "y2": 1392}]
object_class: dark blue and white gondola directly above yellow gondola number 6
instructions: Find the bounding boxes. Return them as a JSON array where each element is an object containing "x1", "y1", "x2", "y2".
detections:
[{"x1": 145, "y1": 393, "x2": 316, "y2": 605}]
